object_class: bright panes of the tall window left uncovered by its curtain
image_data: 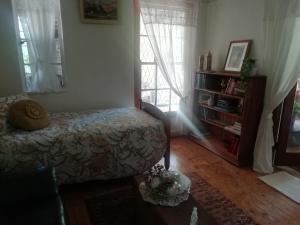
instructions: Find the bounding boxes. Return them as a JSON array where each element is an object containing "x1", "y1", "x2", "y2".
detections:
[{"x1": 139, "y1": 16, "x2": 179, "y2": 112}]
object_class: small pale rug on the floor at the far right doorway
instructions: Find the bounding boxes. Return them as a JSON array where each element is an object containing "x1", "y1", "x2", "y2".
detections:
[{"x1": 258, "y1": 171, "x2": 300, "y2": 204}]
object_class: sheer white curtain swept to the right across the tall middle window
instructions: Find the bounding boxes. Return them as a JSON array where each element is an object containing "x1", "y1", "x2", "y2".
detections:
[{"x1": 140, "y1": 0, "x2": 198, "y2": 102}]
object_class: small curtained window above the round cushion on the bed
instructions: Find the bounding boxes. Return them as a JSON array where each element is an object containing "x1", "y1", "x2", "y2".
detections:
[{"x1": 14, "y1": 0, "x2": 64, "y2": 92}]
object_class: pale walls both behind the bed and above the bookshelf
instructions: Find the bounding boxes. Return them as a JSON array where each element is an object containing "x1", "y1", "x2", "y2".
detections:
[{"x1": 0, "y1": 0, "x2": 263, "y2": 111}]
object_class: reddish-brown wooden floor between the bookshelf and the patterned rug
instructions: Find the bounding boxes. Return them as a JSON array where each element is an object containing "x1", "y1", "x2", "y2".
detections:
[{"x1": 62, "y1": 137, "x2": 300, "y2": 225}]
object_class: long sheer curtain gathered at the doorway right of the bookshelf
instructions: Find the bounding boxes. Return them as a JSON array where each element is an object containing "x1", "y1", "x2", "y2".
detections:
[{"x1": 253, "y1": 0, "x2": 300, "y2": 173}]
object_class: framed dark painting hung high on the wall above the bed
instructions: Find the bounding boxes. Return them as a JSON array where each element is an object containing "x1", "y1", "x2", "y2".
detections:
[{"x1": 80, "y1": 0, "x2": 121, "y2": 24}]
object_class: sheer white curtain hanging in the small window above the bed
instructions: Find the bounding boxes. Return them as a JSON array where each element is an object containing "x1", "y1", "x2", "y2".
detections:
[{"x1": 16, "y1": 0, "x2": 61, "y2": 92}]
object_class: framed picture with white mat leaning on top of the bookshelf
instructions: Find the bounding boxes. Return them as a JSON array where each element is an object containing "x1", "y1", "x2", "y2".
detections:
[{"x1": 224, "y1": 40, "x2": 252, "y2": 72}]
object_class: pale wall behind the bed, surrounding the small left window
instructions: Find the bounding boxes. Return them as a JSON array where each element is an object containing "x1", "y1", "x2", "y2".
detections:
[{"x1": 0, "y1": 0, "x2": 134, "y2": 111}]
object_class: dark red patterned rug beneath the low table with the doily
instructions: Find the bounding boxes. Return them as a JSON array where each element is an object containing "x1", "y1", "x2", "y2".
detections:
[{"x1": 85, "y1": 173, "x2": 257, "y2": 225}]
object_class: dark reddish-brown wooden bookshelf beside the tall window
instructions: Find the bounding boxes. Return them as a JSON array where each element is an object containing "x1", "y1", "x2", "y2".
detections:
[{"x1": 190, "y1": 71, "x2": 266, "y2": 165}]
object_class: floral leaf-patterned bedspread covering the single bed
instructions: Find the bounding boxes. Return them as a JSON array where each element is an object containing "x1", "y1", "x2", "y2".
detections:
[{"x1": 0, "y1": 108, "x2": 167, "y2": 184}]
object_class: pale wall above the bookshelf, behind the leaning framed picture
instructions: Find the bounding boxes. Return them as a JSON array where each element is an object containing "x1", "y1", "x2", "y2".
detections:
[{"x1": 202, "y1": 0, "x2": 264, "y2": 70}]
